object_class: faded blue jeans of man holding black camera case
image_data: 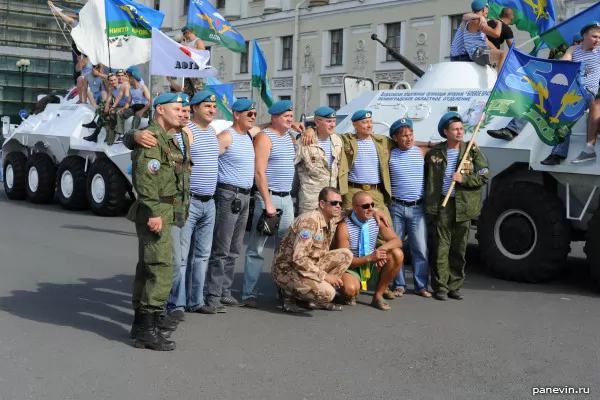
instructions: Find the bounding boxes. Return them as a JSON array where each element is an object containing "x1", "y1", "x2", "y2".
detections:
[{"x1": 242, "y1": 193, "x2": 294, "y2": 300}]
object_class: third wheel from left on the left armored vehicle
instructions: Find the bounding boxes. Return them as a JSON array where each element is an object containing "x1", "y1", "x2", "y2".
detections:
[{"x1": 56, "y1": 156, "x2": 88, "y2": 211}]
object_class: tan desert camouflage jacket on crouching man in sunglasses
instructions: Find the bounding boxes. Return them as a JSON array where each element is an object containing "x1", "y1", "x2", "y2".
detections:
[{"x1": 272, "y1": 210, "x2": 336, "y2": 282}]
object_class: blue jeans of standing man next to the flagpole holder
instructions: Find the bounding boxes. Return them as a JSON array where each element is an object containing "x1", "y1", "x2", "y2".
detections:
[{"x1": 390, "y1": 203, "x2": 429, "y2": 292}]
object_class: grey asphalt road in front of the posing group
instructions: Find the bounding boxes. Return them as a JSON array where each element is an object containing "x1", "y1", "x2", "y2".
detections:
[{"x1": 0, "y1": 190, "x2": 600, "y2": 400}]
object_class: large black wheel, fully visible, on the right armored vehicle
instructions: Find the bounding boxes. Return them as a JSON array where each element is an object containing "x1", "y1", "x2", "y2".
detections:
[{"x1": 478, "y1": 182, "x2": 570, "y2": 283}]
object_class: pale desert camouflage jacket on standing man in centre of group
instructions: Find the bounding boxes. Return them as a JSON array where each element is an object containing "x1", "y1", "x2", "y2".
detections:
[{"x1": 294, "y1": 135, "x2": 342, "y2": 210}]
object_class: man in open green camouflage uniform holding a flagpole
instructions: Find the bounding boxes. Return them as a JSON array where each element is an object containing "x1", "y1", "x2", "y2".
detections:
[{"x1": 425, "y1": 112, "x2": 489, "y2": 300}]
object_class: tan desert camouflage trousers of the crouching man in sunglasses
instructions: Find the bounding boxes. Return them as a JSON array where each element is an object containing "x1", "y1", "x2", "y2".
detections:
[{"x1": 273, "y1": 249, "x2": 354, "y2": 304}]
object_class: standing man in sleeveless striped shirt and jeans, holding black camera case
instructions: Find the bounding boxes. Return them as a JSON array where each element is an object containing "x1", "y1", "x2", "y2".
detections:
[{"x1": 242, "y1": 100, "x2": 296, "y2": 308}]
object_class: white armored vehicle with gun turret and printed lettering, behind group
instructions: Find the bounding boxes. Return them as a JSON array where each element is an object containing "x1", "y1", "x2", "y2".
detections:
[{"x1": 337, "y1": 35, "x2": 600, "y2": 282}]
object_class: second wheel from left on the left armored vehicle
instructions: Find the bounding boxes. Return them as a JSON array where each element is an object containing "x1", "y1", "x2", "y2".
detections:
[{"x1": 25, "y1": 153, "x2": 56, "y2": 204}]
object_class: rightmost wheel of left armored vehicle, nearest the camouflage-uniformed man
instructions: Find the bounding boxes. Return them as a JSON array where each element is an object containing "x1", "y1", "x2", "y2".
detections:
[{"x1": 86, "y1": 158, "x2": 126, "y2": 217}]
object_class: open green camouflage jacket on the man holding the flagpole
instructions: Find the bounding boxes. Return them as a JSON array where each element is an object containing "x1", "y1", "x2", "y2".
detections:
[{"x1": 425, "y1": 142, "x2": 490, "y2": 222}]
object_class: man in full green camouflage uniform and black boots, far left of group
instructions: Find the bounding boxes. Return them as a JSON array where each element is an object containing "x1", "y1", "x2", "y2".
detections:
[{"x1": 127, "y1": 93, "x2": 189, "y2": 351}]
